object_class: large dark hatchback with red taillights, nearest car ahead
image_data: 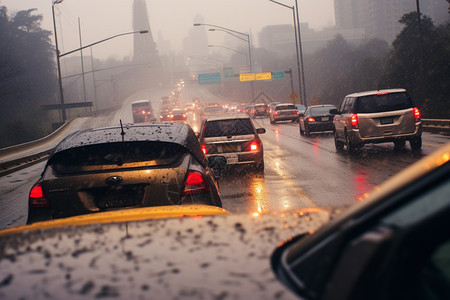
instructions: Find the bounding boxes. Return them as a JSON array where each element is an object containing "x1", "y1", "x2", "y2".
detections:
[{"x1": 27, "y1": 123, "x2": 222, "y2": 223}]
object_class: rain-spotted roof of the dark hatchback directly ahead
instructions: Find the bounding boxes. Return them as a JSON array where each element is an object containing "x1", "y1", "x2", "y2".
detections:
[{"x1": 54, "y1": 123, "x2": 206, "y2": 165}]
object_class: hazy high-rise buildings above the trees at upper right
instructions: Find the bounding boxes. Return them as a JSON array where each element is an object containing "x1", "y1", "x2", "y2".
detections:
[{"x1": 334, "y1": 0, "x2": 449, "y2": 42}]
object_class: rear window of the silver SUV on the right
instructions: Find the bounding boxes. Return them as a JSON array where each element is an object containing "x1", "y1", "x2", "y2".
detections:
[{"x1": 355, "y1": 93, "x2": 413, "y2": 113}]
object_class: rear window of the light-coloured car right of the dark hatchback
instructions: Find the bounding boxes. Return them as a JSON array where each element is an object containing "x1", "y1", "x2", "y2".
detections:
[{"x1": 203, "y1": 119, "x2": 255, "y2": 137}]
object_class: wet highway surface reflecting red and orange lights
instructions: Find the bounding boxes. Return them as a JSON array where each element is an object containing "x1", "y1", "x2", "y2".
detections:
[{"x1": 0, "y1": 85, "x2": 449, "y2": 229}]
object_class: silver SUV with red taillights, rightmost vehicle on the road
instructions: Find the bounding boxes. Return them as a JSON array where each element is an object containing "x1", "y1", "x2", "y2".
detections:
[{"x1": 333, "y1": 89, "x2": 422, "y2": 151}]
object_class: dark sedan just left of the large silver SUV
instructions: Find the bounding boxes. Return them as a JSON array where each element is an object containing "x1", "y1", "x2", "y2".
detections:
[{"x1": 298, "y1": 104, "x2": 336, "y2": 136}]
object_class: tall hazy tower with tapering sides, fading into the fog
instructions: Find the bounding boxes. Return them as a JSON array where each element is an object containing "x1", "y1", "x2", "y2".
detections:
[{"x1": 133, "y1": 0, "x2": 159, "y2": 66}]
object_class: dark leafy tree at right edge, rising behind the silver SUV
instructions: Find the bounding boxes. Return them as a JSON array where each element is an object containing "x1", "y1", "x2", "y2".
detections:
[{"x1": 383, "y1": 12, "x2": 450, "y2": 117}]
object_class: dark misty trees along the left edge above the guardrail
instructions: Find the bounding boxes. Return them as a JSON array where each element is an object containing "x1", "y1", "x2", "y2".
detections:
[{"x1": 0, "y1": 6, "x2": 57, "y2": 147}]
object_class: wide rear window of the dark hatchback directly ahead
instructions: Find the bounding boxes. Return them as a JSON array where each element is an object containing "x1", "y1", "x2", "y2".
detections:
[{"x1": 48, "y1": 141, "x2": 188, "y2": 175}]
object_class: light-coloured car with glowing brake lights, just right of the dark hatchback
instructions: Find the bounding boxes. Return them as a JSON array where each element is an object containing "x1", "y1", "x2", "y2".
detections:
[{"x1": 199, "y1": 114, "x2": 266, "y2": 172}]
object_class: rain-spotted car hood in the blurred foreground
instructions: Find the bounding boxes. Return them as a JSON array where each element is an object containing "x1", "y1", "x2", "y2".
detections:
[{"x1": 0, "y1": 205, "x2": 331, "y2": 299}]
